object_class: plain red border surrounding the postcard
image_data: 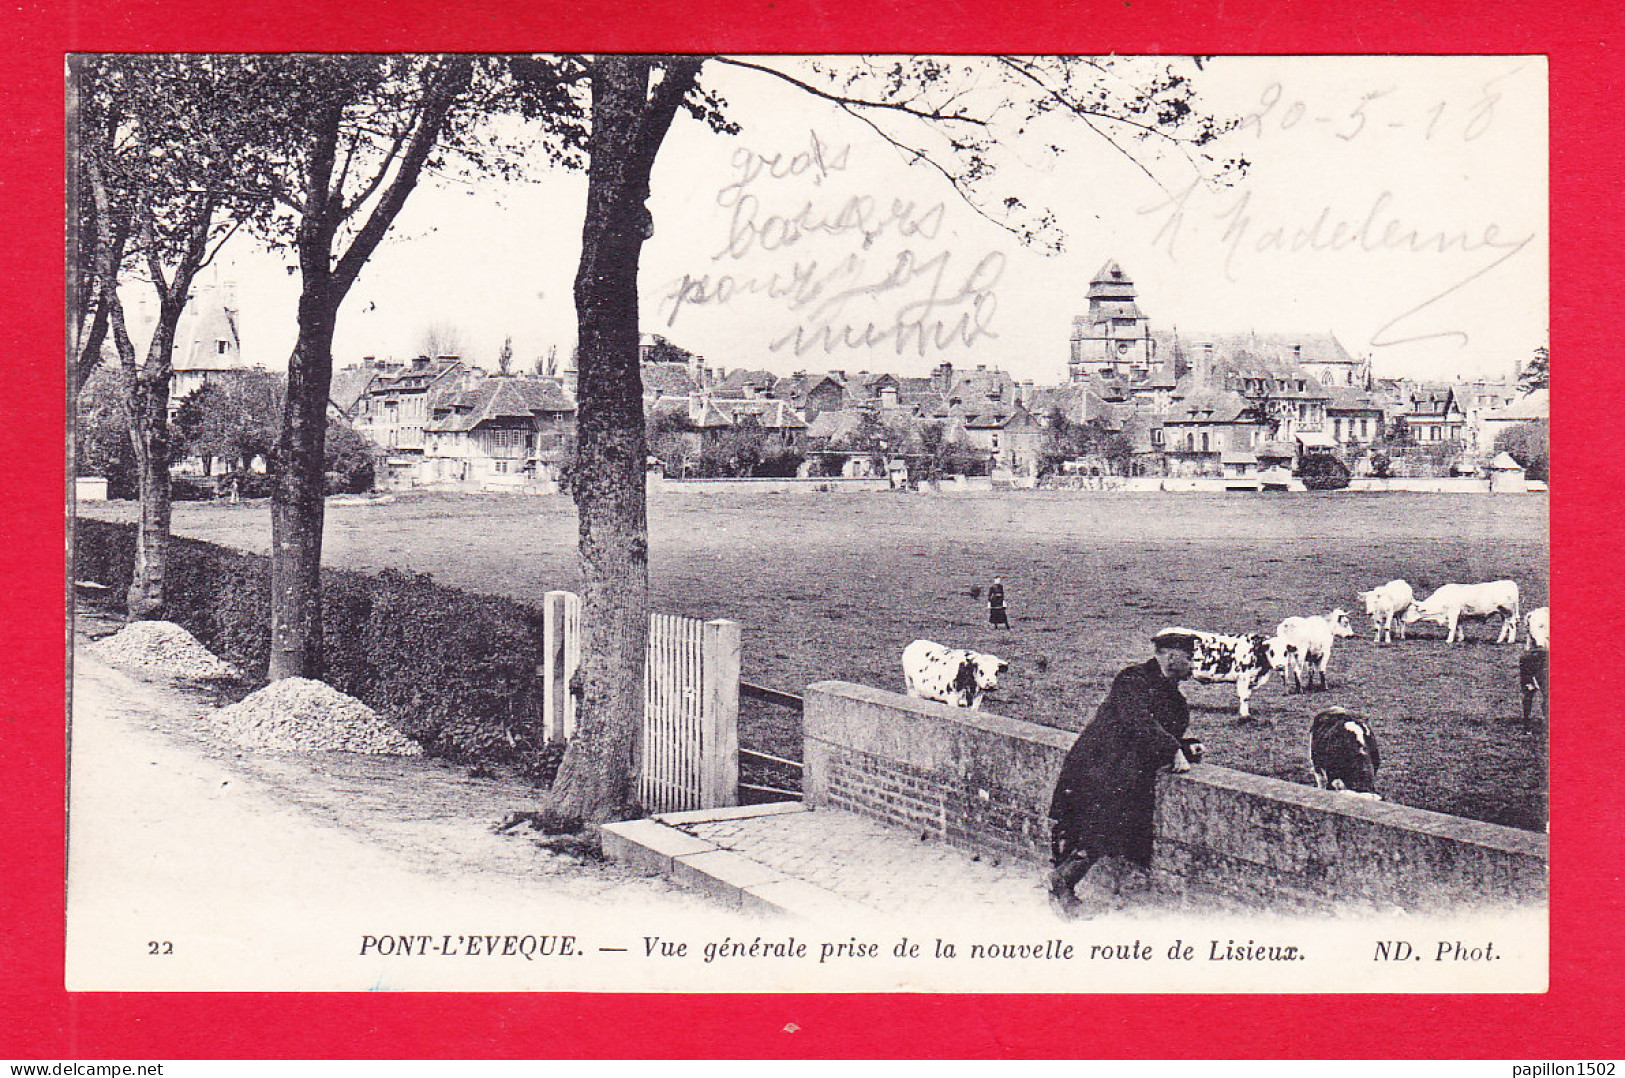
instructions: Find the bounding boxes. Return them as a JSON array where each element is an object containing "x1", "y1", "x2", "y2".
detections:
[{"x1": 0, "y1": 0, "x2": 1625, "y2": 1060}]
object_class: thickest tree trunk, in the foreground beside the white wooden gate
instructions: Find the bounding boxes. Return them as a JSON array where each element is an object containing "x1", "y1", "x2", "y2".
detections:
[{"x1": 520, "y1": 57, "x2": 699, "y2": 831}]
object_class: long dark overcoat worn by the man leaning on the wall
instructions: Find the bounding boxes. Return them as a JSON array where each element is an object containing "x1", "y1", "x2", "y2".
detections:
[{"x1": 1050, "y1": 659, "x2": 1191, "y2": 865}]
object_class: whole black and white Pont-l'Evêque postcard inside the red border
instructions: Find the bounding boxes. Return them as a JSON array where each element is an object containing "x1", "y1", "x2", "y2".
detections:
[{"x1": 65, "y1": 52, "x2": 1547, "y2": 993}]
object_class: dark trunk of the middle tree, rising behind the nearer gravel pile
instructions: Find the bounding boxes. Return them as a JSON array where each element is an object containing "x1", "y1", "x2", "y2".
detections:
[{"x1": 268, "y1": 282, "x2": 338, "y2": 681}]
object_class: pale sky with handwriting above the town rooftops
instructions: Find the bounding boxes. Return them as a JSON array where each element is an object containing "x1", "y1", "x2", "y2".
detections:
[{"x1": 130, "y1": 57, "x2": 1549, "y2": 384}]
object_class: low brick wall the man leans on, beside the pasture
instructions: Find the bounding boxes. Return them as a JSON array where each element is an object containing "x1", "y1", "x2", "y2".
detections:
[{"x1": 803, "y1": 681, "x2": 1547, "y2": 909}]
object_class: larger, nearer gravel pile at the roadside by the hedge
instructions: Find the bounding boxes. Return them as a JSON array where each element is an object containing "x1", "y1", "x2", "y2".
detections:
[{"x1": 215, "y1": 678, "x2": 423, "y2": 756}]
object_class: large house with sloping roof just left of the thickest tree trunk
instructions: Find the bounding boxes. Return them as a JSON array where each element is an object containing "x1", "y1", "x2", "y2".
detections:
[{"x1": 414, "y1": 376, "x2": 575, "y2": 486}]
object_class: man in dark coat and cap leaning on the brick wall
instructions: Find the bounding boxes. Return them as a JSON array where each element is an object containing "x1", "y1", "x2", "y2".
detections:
[{"x1": 1048, "y1": 632, "x2": 1203, "y2": 920}]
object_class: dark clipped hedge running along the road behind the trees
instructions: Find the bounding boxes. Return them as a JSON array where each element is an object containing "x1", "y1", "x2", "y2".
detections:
[{"x1": 73, "y1": 520, "x2": 557, "y2": 779}]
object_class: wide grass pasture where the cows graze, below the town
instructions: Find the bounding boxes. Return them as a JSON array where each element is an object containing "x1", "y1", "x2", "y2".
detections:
[{"x1": 85, "y1": 491, "x2": 1549, "y2": 829}]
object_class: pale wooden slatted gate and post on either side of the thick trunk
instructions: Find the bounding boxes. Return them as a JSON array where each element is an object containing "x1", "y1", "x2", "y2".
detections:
[{"x1": 543, "y1": 592, "x2": 739, "y2": 813}]
